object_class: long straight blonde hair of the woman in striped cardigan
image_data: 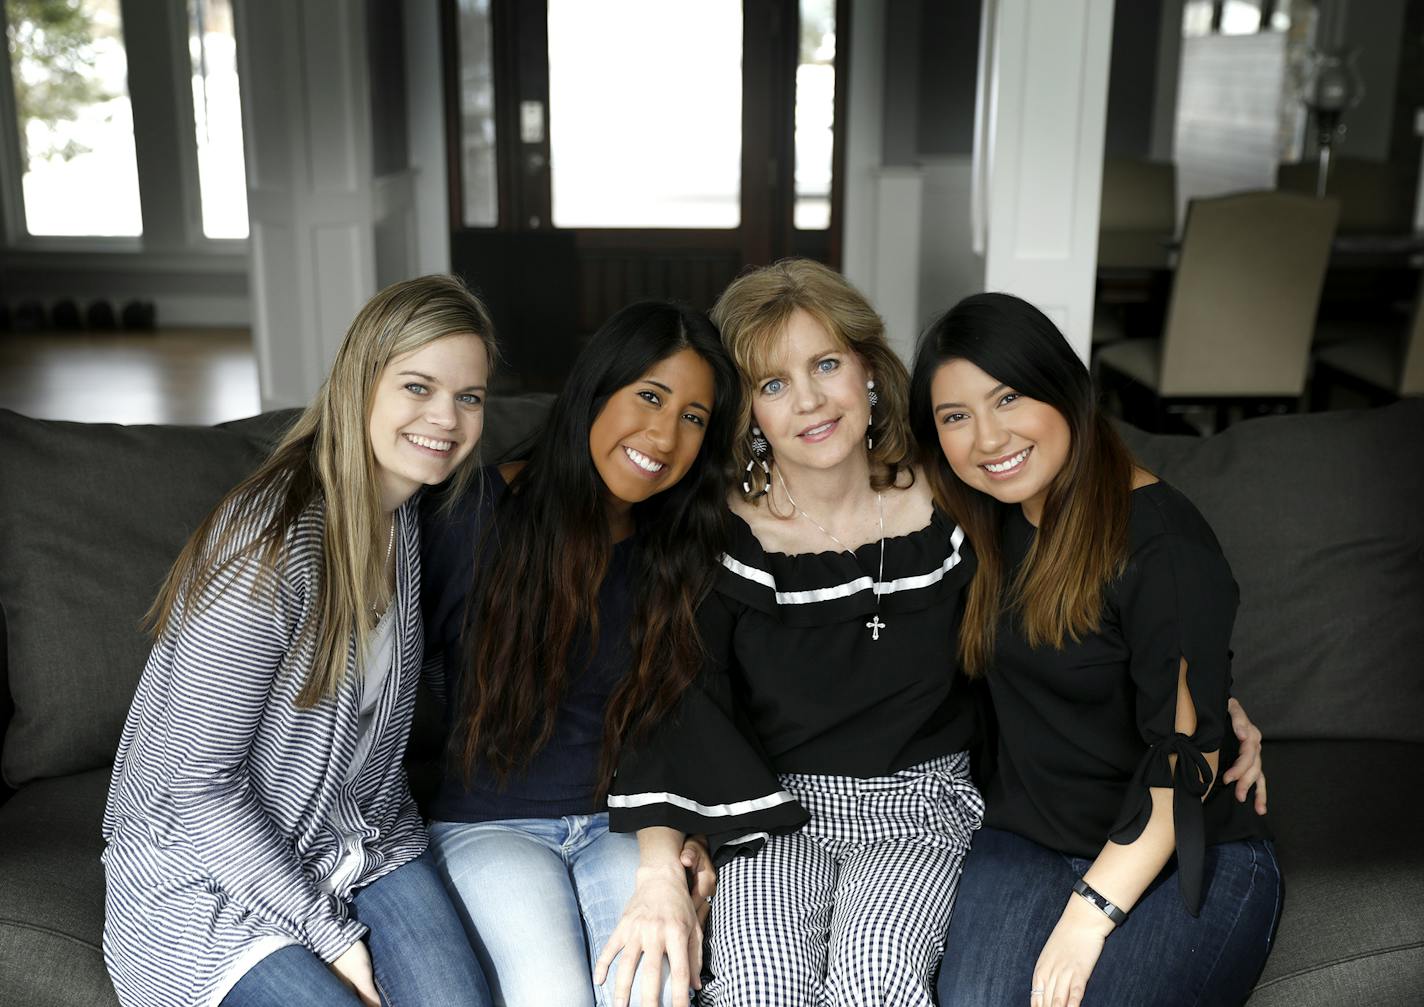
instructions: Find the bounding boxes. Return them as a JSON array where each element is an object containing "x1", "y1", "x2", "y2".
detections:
[{"x1": 144, "y1": 276, "x2": 496, "y2": 706}]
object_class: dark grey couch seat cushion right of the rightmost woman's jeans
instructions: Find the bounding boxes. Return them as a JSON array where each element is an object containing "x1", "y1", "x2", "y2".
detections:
[{"x1": 1250, "y1": 741, "x2": 1424, "y2": 1007}]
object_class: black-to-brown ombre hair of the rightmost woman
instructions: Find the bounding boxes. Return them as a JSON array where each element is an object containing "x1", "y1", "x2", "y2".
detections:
[{"x1": 910, "y1": 293, "x2": 1134, "y2": 677}]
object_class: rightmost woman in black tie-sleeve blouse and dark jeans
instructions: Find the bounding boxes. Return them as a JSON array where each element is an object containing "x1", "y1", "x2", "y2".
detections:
[{"x1": 910, "y1": 293, "x2": 1280, "y2": 1007}]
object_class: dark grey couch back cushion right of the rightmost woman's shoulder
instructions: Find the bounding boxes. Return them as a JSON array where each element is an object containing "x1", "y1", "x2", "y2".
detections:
[{"x1": 1124, "y1": 400, "x2": 1424, "y2": 742}]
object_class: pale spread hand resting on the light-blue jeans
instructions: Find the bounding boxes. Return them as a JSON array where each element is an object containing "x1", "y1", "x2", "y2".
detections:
[{"x1": 594, "y1": 857, "x2": 711, "y2": 1007}]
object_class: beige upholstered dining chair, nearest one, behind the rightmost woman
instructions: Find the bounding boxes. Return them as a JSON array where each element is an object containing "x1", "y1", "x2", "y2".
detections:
[{"x1": 1095, "y1": 192, "x2": 1339, "y2": 430}]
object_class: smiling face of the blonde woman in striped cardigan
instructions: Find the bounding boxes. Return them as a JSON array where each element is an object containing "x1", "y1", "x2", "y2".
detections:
[{"x1": 367, "y1": 335, "x2": 490, "y2": 510}]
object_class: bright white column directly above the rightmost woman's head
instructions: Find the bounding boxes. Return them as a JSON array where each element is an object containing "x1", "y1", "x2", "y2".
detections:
[{"x1": 975, "y1": 0, "x2": 1112, "y2": 360}]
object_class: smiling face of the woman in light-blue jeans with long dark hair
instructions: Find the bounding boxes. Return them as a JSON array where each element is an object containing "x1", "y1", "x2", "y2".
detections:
[{"x1": 588, "y1": 349, "x2": 715, "y2": 504}]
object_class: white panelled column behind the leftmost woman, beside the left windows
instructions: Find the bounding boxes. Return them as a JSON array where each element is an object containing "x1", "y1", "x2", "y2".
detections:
[{"x1": 235, "y1": 0, "x2": 410, "y2": 409}]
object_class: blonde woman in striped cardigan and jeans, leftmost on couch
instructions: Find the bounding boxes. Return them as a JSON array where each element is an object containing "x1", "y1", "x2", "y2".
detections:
[{"x1": 104, "y1": 276, "x2": 494, "y2": 1007}]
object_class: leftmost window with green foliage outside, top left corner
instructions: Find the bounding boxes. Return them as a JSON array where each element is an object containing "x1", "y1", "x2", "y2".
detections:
[{"x1": 6, "y1": 0, "x2": 144, "y2": 236}]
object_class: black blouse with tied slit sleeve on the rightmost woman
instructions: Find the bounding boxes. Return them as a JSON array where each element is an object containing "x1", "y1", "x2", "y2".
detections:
[{"x1": 984, "y1": 483, "x2": 1267, "y2": 913}]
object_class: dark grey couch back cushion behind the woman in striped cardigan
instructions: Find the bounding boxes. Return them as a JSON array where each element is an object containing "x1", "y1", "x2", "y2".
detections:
[{"x1": 0, "y1": 396, "x2": 550, "y2": 786}]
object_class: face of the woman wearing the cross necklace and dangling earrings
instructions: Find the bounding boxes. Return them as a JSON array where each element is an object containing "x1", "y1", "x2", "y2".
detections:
[{"x1": 752, "y1": 309, "x2": 870, "y2": 469}]
